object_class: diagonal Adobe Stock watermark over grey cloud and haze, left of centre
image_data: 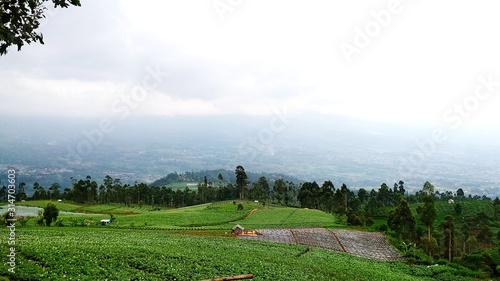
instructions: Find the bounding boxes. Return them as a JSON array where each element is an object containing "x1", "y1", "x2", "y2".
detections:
[{"x1": 65, "y1": 65, "x2": 169, "y2": 161}]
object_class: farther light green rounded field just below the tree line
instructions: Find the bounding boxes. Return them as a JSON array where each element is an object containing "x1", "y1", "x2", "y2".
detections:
[{"x1": 17, "y1": 200, "x2": 339, "y2": 231}]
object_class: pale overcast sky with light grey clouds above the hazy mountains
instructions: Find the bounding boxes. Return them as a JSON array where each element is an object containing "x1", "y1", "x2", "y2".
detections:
[{"x1": 0, "y1": 0, "x2": 500, "y2": 129}]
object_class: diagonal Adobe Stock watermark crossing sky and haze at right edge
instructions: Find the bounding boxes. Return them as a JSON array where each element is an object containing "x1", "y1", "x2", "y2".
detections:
[{"x1": 399, "y1": 74, "x2": 500, "y2": 173}]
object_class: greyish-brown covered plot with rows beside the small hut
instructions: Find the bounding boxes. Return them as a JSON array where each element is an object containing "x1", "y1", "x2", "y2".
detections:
[{"x1": 239, "y1": 227, "x2": 403, "y2": 261}]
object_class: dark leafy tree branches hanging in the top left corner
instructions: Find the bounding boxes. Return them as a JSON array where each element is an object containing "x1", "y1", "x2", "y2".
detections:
[{"x1": 0, "y1": 0, "x2": 80, "y2": 56}]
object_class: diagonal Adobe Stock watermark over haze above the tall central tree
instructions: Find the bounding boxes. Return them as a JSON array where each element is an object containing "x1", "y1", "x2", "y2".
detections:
[{"x1": 238, "y1": 107, "x2": 298, "y2": 161}]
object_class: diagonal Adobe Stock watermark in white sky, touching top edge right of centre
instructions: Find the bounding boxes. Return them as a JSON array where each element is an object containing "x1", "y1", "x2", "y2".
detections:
[{"x1": 339, "y1": 0, "x2": 411, "y2": 63}]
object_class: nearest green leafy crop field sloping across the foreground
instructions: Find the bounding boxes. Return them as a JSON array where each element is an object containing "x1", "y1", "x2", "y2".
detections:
[{"x1": 0, "y1": 227, "x2": 478, "y2": 281}]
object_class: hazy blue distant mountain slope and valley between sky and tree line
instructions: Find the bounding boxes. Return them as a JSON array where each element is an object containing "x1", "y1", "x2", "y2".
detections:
[{"x1": 0, "y1": 114, "x2": 500, "y2": 196}]
